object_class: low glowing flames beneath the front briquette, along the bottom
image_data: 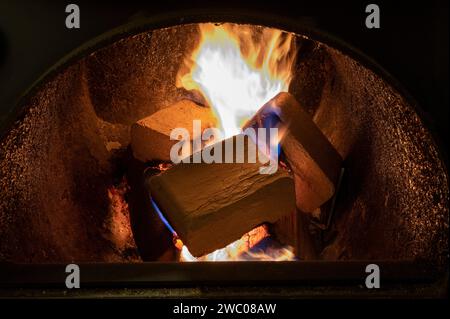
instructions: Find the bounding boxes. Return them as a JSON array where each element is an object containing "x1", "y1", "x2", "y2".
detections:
[{"x1": 177, "y1": 225, "x2": 295, "y2": 262}]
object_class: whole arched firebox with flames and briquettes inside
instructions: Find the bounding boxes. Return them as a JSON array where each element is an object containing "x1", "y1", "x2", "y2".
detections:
[{"x1": 0, "y1": 8, "x2": 449, "y2": 298}]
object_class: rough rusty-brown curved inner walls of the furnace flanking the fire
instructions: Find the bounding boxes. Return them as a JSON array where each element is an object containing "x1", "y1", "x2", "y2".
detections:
[{"x1": 0, "y1": 24, "x2": 449, "y2": 263}]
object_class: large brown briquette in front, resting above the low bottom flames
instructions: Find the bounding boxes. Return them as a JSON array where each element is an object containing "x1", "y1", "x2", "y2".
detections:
[{"x1": 148, "y1": 135, "x2": 295, "y2": 257}]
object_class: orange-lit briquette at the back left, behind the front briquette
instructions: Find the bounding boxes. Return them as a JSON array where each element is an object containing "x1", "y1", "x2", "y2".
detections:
[{"x1": 131, "y1": 100, "x2": 216, "y2": 162}]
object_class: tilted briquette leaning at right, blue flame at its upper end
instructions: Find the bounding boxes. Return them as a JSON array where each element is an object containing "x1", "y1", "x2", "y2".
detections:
[{"x1": 246, "y1": 92, "x2": 342, "y2": 212}]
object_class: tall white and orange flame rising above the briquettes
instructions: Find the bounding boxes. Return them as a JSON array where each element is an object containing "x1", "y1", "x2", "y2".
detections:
[{"x1": 176, "y1": 24, "x2": 296, "y2": 138}]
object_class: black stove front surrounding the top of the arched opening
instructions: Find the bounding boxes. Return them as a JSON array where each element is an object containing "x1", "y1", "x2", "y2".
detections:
[{"x1": 0, "y1": 0, "x2": 449, "y2": 148}]
